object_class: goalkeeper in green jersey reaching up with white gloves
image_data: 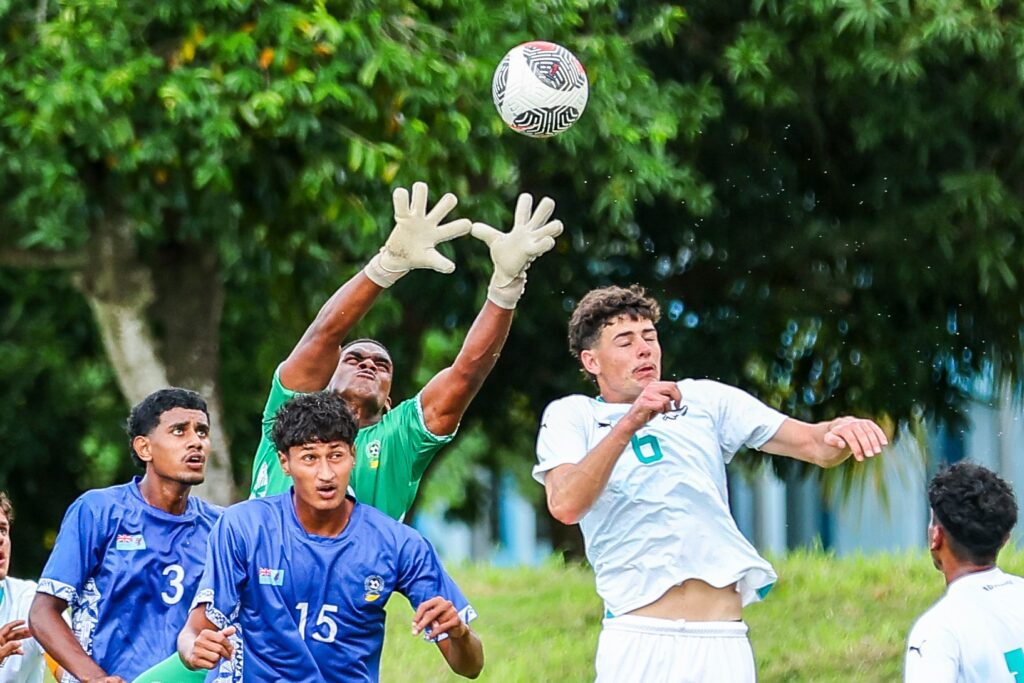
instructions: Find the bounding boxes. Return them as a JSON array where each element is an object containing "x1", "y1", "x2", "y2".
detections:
[{"x1": 251, "y1": 182, "x2": 562, "y2": 520}]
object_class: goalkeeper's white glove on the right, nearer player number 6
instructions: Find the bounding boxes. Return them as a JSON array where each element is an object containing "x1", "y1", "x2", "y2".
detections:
[{"x1": 472, "y1": 194, "x2": 562, "y2": 309}]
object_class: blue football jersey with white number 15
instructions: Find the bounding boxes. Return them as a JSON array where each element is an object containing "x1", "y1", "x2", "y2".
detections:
[{"x1": 194, "y1": 492, "x2": 476, "y2": 682}]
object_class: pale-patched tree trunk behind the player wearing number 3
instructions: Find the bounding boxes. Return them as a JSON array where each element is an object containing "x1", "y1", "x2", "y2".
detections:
[{"x1": 77, "y1": 217, "x2": 237, "y2": 505}]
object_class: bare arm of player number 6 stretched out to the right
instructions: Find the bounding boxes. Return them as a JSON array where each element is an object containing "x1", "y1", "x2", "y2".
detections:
[{"x1": 760, "y1": 417, "x2": 889, "y2": 467}]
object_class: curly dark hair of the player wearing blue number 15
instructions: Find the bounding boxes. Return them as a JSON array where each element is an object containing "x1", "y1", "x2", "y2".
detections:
[{"x1": 270, "y1": 391, "x2": 358, "y2": 454}]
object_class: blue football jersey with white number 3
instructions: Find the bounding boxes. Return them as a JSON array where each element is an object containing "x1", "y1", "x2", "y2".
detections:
[{"x1": 37, "y1": 477, "x2": 223, "y2": 681}]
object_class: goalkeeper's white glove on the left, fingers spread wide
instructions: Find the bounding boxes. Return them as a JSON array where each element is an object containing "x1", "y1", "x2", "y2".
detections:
[{"x1": 362, "y1": 182, "x2": 472, "y2": 289}]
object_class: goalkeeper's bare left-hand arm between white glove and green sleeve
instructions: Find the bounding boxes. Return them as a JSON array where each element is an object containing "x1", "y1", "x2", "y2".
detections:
[{"x1": 281, "y1": 272, "x2": 384, "y2": 391}]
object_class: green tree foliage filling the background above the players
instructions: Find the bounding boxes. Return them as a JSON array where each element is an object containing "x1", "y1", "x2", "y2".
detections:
[{"x1": 0, "y1": 0, "x2": 1024, "y2": 565}]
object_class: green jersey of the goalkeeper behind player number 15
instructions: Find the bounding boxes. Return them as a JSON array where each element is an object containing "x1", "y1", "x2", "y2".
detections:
[{"x1": 249, "y1": 368, "x2": 455, "y2": 520}]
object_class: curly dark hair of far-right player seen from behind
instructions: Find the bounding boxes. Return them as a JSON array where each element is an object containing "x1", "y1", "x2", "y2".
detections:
[{"x1": 928, "y1": 462, "x2": 1017, "y2": 565}]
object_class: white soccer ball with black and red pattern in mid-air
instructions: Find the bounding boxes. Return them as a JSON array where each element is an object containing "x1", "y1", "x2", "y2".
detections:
[{"x1": 490, "y1": 40, "x2": 590, "y2": 137}]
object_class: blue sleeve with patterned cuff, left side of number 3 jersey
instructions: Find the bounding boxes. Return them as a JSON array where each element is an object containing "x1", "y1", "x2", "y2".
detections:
[{"x1": 38, "y1": 496, "x2": 106, "y2": 603}]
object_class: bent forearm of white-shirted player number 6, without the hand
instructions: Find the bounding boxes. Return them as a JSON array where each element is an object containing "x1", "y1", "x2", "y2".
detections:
[{"x1": 546, "y1": 420, "x2": 636, "y2": 524}]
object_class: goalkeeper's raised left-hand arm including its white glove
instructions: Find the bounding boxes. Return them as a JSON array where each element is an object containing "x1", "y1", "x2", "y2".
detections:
[{"x1": 281, "y1": 182, "x2": 472, "y2": 391}]
